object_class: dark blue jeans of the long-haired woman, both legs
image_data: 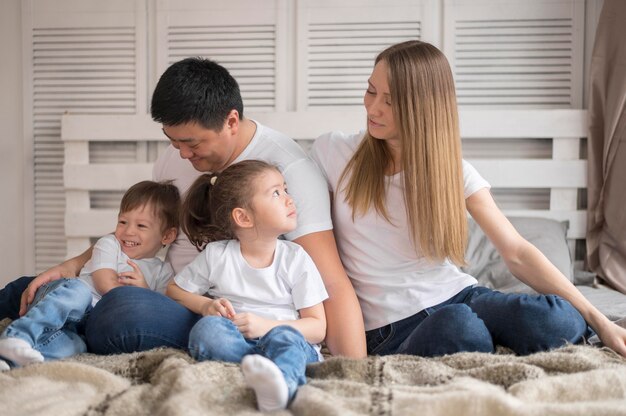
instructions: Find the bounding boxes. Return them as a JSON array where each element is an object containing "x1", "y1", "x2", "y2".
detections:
[{"x1": 366, "y1": 286, "x2": 591, "y2": 357}]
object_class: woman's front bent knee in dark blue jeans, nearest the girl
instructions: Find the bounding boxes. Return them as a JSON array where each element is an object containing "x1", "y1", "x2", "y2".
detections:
[{"x1": 396, "y1": 303, "x2": 494, "y2": 357}]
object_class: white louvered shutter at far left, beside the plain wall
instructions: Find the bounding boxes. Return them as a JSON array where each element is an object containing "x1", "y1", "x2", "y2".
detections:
[{"x1": 23, "y1": 0, "x2": 146, "y2": 271}]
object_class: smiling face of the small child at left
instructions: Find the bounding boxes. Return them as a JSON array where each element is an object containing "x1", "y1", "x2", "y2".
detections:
[{"x1": 115, "y1": 205, "x2": 167, "y2": 259}]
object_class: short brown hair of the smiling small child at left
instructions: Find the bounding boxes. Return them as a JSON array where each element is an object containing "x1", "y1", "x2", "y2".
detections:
[{"x1": 120, "y1": 181, "x2": 180, "y2": 233}]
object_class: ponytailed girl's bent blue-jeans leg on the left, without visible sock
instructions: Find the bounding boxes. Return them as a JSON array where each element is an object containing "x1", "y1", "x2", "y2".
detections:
[{"x1": 189, "y1": 316, "x2": 256, "y2": 363}]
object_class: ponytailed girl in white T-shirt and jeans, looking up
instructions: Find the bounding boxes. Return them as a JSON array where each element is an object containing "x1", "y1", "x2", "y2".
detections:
[{"x1": 167, "y1": 160, "x2": 328, "y2": 411}]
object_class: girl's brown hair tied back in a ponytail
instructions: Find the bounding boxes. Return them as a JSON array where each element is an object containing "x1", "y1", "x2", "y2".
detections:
[{"x1": 181, "y1": 160, "x2": 278, "y2": 251}]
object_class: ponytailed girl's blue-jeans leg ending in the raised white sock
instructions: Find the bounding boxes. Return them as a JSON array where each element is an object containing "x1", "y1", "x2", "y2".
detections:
[{"x1": 256, "y1": 325, "x2": 319, "y2": 400}]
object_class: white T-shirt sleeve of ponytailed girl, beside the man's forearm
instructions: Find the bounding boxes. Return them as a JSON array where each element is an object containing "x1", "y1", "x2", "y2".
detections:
[{"x1": 290, "y1": 248, "x2": 328, "y2": 310}]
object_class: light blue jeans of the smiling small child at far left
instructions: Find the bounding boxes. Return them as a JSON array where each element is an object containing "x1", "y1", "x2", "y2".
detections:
[{"x1": 1, "y1": 279, "x2": 92, "y2": 360}]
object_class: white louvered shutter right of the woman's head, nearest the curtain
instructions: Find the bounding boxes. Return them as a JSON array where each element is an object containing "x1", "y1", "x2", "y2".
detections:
[{"x1": 444, "y1": 0, "x2": 584, "y2": 108}]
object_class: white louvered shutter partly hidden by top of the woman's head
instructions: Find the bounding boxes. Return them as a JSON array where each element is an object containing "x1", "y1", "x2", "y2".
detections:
[{"x1": 296, "y1": 0, "x2": 438, "y2": 111}]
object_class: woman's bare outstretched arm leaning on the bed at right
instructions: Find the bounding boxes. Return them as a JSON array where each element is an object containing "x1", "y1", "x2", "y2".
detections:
[{"x1": 466, "y1": 189, "x2": 626, "y2": 356}]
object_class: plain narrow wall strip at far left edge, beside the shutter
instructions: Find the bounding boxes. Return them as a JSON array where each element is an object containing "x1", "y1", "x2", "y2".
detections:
[{"x1": 0, "y1": 0, "x2": 27, "y2": 287}]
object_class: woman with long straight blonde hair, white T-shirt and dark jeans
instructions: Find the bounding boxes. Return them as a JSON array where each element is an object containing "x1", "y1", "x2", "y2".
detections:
[{"x1": 313, "y1": 41, "x2": 626, "y2": 356}]
